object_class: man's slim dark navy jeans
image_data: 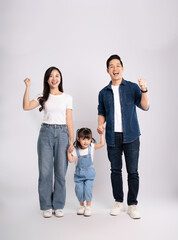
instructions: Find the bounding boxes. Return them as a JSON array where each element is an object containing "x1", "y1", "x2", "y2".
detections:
[{"x1": 107, "y1": 133, "x2": 140, "y2": 205}]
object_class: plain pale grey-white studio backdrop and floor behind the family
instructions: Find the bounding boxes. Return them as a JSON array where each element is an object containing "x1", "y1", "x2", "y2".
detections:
[{"x1": 0, "y1": 0, "x2": 178, "y2": 240}]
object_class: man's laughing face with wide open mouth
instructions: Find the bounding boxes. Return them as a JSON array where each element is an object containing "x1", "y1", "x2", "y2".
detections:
[{"x1": 107, "y1": 59, "x2": 124, "y2": 81}]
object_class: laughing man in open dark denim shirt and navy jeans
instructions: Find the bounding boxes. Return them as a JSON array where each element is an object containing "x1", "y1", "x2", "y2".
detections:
[{"x1": 97, "y1": 55, "x2": 149, "y2": 219}]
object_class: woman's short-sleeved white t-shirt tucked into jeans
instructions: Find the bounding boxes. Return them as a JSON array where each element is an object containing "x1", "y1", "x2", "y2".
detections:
[{"x1": 34, "y1": 93, "x2": 72, "y2": 124}]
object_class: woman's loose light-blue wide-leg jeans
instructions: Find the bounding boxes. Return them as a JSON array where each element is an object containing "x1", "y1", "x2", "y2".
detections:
[{"x1": 37, "y1": 123, "x2": 69, "y2": 210}]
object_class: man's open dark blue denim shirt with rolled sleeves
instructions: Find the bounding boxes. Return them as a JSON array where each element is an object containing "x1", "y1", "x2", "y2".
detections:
[{"x1": 98, "y1": 79, "x2": 148, "y2": 146}]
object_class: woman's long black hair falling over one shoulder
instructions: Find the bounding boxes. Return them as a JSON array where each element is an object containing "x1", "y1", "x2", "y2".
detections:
[{"x1": 38, "y1": 67, "x2": 64, "y2": 112}]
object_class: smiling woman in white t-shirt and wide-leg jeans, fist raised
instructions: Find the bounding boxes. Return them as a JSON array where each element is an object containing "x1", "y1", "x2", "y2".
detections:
[{"x1": 23, "y1": 67, "x2": 73, "y2": 218}]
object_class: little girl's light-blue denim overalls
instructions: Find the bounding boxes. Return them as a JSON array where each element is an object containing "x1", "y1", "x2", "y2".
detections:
[{"x1": 74, "y1": 146, "x2": 96, "y2": 202}]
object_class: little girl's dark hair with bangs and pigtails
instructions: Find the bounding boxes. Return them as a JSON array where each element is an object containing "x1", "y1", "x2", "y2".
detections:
[{"x1": 74, "y1": 128, "x2": 96, "y2": 148}]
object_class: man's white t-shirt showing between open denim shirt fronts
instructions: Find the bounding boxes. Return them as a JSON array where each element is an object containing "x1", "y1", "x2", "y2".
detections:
[{"x1": 111, "y1": 85, "x2": 123, "y2": 132}]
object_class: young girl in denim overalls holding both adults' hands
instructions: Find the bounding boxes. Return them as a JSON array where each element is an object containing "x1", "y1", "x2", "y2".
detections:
[{"x1": 68, "y1": 128, "x2": 105, "y2": 217}]
